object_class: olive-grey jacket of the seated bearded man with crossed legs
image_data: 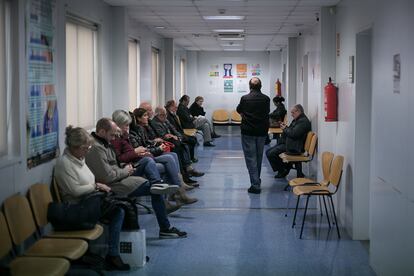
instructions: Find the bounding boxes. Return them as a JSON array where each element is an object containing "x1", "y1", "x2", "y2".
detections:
[{"x1": 85, "y1": 132, "x2": 147, "y2": 195}]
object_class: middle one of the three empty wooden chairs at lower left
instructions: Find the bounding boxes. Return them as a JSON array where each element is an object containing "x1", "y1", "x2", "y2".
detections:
[{"x1": 4, "y1": 195, "x2": 88, "y2": 260}]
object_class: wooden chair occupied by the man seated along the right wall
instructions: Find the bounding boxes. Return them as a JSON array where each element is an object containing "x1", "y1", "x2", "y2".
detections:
[{"x1": 279, "y1": 131, "x2": 318, "y2": 177}]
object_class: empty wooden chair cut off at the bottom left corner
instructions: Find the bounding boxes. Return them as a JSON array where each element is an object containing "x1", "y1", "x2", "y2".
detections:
[{"x1": 0, "y1": 211, "x2": 70, "y2": 276}]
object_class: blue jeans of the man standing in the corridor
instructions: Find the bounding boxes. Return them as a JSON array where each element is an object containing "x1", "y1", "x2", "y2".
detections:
[{"x1": 241, "y1": 134, "x2": 266, "y2": 188}]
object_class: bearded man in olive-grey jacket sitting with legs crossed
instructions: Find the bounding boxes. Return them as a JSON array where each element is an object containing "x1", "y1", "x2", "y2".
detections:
[{"x1": 85, "y1": 118, "x2": 187, "y2": 238}]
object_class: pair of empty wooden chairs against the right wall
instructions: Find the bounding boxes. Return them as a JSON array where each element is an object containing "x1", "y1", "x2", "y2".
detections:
[{"x1": 285, "y1": 151, "x2": 344, "y2": 239}]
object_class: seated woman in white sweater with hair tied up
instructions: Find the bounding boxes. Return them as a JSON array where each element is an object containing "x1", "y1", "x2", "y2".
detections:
[{"x1": 55, "y1": 126, "x2": 130, "y2": 270}]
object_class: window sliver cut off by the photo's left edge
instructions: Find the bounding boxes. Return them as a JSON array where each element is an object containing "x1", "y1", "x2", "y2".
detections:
[{"x1": 0, "y1": 0, "x2": 10, "y2": 156}]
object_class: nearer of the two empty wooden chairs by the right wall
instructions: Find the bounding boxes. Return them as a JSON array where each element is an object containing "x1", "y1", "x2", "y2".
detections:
[{"x1": 293, "y1": 155, "x2": 344, "y2": 239}]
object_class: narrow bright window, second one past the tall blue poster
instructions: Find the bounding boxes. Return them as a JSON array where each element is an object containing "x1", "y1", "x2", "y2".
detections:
[{"x1": 128, "y1": 40, "x2": 140, "y2": 111}]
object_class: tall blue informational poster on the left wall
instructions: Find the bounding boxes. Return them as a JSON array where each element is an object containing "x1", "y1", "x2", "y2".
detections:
[{"x1": 26, "y1": 0, "x2": 59, "y2": 168}]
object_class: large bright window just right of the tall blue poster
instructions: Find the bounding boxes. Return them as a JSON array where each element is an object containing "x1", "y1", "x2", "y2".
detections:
[{"x1": 66, "y1": 16, "x2": 97, "y2": 129}]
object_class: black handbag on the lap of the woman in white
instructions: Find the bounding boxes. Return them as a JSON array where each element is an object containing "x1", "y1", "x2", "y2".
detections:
[{"x1": 47, "y1": 192, "x2": 104, "y2": 231}]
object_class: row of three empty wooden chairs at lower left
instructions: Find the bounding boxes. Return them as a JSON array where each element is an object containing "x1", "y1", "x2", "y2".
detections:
[{"x1": 0, "y1": 184, "x2": 103, "y2": 275}]
